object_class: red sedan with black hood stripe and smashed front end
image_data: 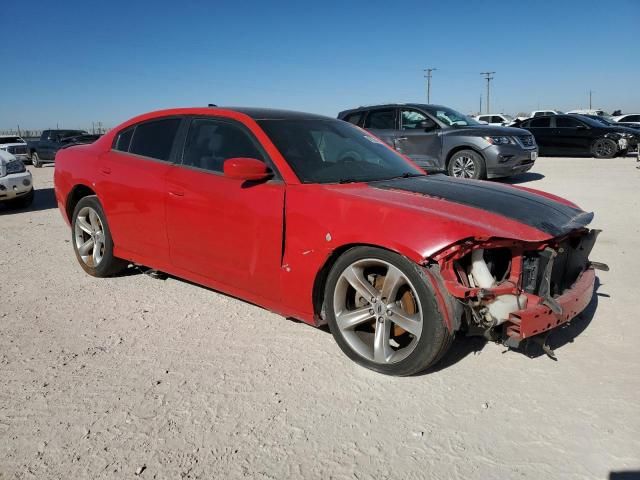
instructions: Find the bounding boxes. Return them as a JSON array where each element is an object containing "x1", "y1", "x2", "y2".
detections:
[{"x1": 55, "y1": 108, "x2": 598, "y2": 375}]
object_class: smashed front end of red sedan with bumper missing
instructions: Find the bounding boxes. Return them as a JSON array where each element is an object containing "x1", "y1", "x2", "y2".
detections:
[{"x1": 429, "y1": 228, "x2": 608, "y2": 355}]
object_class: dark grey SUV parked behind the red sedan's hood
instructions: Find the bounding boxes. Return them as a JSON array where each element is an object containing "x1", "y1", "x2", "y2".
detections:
[{"x1": 338, "y1": 103, "x2": 538, "y2": 178}]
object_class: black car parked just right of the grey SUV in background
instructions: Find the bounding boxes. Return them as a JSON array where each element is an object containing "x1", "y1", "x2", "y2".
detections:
[{"x1": 519, "y1": 114, "x2": 640, "y2": 158}]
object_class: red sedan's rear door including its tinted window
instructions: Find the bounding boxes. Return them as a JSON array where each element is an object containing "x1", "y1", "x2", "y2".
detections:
[{"x1": 99, "y1": 117, "x2": 182, "y2": 265}]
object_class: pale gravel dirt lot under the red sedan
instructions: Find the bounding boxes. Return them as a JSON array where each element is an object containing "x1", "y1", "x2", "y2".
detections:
[{"x1": 0, "y1": 157, "x2": 640, "y2": 479}]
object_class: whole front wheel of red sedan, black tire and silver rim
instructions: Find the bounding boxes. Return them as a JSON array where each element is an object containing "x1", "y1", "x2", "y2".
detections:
[{"x1": 324, "y1": 247, "x2": 453, "y2": 376}]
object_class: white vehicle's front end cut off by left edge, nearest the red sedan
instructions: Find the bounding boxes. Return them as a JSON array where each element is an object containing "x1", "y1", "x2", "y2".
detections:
[{"x1": 0, "y1": 149, "x2": 34, "y2": 208}]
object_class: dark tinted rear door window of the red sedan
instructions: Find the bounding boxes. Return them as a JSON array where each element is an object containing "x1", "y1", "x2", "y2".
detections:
[{"x1": 129, "y1": 118, "x2": 181, "y2": 161}]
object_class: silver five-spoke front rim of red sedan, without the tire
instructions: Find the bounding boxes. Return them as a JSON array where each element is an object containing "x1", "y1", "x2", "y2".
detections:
[{"x1": 333, "y1": 258, "x2": 423, "y2": 364}]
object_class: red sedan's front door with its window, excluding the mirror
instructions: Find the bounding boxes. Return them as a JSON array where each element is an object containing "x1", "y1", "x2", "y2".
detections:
[{"x1": 166, "y1": 117, "x2": 285, "y2": 299}]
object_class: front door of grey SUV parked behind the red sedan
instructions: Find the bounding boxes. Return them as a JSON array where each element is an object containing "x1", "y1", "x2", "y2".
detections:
[{"x1": 395, "y1": 108, "x2": 443, "y2": 171}]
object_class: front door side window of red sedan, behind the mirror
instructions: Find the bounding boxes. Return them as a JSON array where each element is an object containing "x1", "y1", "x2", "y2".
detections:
[{"x1": 182, "y1": 119, "x2": 265, "y2": 172}]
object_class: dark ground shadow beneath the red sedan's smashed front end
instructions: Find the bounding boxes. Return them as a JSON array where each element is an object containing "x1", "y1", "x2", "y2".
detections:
[{"x1": 417, "y1": 277, "x2": 609, "y2": 375}]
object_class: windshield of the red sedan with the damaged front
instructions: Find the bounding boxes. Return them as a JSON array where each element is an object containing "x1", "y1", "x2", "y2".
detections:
[{"x1": 258, "y1": 120, "x2": 424, "y2": 183}]
